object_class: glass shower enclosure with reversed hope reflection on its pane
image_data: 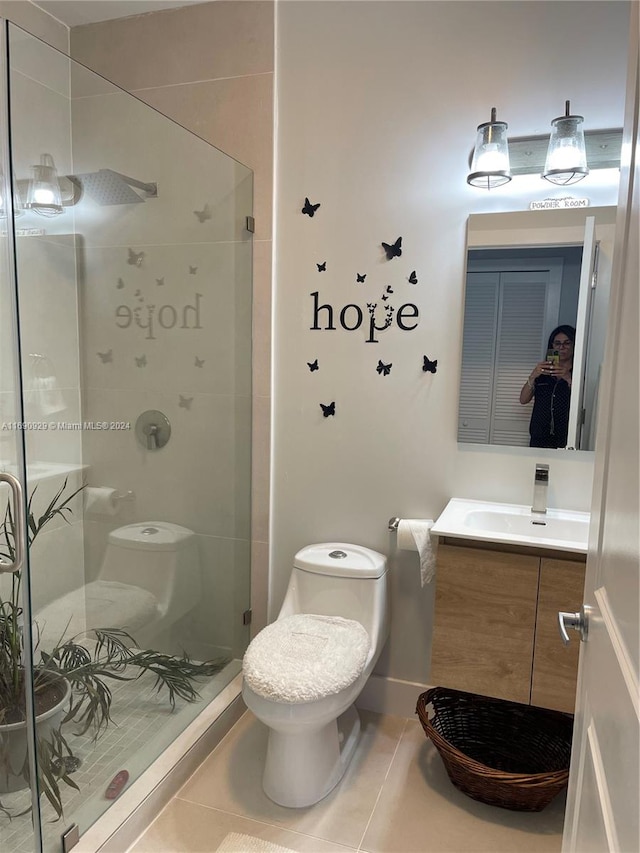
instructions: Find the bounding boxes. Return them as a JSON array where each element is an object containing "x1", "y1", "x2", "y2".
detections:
[{"x1": 0, "y1": 21, "x2": 253, "y2": 853}]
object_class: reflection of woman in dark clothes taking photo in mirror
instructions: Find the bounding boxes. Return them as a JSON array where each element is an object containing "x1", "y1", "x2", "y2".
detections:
[{"x1": 520, "y1": 326, "x2": 576, "y2": 447}]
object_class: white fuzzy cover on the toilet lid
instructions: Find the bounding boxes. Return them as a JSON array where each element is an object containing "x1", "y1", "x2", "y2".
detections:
[{"x1": 242, "y1": 613, "x2": 370, "y2": 704}]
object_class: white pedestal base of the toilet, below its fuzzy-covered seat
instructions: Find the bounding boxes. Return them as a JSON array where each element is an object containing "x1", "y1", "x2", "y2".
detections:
[{"x1": 262, "y1": 705, "x2": 360, "y2": 808}]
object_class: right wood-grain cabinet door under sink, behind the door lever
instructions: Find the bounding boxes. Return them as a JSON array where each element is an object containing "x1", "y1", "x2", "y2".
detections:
[{"x1": 531, "y1": 558, "x2": 585, "y2": 714}]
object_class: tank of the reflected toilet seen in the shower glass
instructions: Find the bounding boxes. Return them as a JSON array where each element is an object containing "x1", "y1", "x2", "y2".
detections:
[{"x1": 100, "y1": 521, "x2": 200, "y2": 618}]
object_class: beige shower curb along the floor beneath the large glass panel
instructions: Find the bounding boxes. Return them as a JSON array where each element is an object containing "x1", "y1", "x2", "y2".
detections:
[{"x1": 73, "y1": 675, "x2": 246, "y2": 853}]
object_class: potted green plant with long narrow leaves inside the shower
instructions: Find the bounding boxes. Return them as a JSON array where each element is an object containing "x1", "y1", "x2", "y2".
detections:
[{"x1": 0, "y1": 479, "x2": 228, "y2": 818}]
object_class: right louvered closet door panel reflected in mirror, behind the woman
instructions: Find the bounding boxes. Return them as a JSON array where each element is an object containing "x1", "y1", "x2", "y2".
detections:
[{"x1": 489, "y1": 270, "x2": 549, "y2": 446}]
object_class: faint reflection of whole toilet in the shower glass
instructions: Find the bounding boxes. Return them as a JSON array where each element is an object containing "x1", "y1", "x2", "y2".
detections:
[{"x1": 35, "y1": 521, "x2": 200, "y2": 651}]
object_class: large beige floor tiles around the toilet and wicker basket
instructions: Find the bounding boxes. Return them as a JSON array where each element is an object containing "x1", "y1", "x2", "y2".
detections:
[{"x1": 128, "y1": 711, "x2": 565, "y2": 853}]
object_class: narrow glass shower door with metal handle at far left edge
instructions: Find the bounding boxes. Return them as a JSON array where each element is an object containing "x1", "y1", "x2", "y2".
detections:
[{"x1": 0, "y1": 21, "x2": 40, "y2": 853}]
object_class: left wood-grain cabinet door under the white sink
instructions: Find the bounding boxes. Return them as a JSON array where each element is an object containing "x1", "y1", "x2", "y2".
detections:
[{"x1": 429, "y1": 545, "x2": 540, "y2": 703}]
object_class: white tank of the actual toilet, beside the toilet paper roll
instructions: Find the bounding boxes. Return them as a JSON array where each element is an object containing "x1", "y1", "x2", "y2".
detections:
[{"x1": 278, "y1": 542, "x2": 389, "y2": 646}]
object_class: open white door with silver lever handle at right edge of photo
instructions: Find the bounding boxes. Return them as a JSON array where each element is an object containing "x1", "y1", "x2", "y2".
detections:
[{"x1": 563, "y1": 8, "x2": 640, "y2": 853}]
